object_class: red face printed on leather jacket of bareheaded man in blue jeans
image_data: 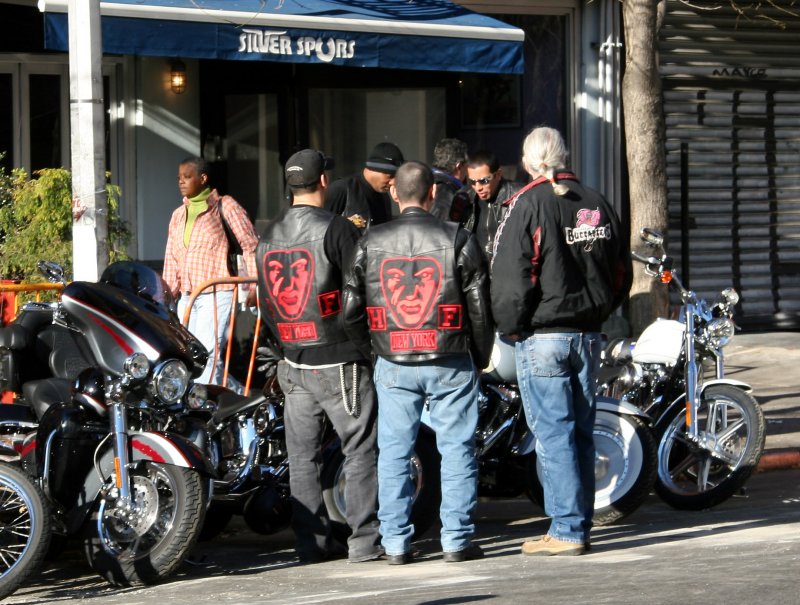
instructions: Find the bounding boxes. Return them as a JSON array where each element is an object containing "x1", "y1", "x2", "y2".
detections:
[{"x1": 381, "y1": 257, "x2": 442, "y2": 329}]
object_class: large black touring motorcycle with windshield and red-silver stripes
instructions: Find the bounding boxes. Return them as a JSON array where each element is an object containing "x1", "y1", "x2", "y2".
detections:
[{"x1": 0, "y1": 262, "x2": 214, "y2": 586}]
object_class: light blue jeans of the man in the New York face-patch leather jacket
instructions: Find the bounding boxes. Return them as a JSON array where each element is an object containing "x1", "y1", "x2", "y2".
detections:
[{"x1": 375, "y1": 355, "x2": 478, "y2": 555}]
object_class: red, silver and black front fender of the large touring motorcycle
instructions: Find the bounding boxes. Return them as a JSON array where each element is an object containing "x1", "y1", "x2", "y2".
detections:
[{"x1": 66, "y1": 432, "x2": 214, "y2": 535}]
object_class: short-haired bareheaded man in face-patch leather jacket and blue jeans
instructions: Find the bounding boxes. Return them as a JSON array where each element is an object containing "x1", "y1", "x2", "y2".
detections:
[{"x1": 344, "y1": 162, "x2": 494, "y2": 565}]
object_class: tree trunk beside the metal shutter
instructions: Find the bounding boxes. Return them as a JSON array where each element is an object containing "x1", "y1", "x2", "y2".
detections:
[{"x1": 622, "y1": 0, "x2": 669, "y2": 336}]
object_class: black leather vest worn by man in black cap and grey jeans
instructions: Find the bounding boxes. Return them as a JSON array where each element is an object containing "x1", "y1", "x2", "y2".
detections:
[{"x1": 256, "y1": 206, "x2": 347, "y2": 349}]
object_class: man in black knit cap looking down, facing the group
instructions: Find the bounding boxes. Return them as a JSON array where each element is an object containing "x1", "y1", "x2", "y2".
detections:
[{"x1": 325, "y1": 142, "x2": 404, "y2": 231}]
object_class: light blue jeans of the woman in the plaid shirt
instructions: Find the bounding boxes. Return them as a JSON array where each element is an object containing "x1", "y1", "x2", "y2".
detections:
[{"x1": 178, "y1": 290, "x2": 237, "y2": 390}]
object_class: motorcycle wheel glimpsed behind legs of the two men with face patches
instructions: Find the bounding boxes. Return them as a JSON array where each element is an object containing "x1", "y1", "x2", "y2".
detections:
[{"x1": 322, "y1": 430, "x2": 442, "y2": 539}]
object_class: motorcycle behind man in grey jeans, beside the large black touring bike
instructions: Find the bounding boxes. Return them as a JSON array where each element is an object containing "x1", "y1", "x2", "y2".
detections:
[{"x1": 180, "y1": 348, "x2": 438, "y2": 542}]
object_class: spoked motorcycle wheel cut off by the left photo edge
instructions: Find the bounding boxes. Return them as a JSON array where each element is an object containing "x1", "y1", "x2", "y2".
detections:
[{"x1": 0, "y1": 463, "x2": 52, "y2": 600}]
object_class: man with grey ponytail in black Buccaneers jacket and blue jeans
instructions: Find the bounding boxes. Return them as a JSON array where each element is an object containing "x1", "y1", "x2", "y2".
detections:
[{"x1": 491, "y1": 128, "x2": 631, "y2": 555}]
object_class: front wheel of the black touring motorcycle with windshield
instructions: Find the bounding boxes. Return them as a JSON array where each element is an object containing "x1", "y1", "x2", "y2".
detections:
[{"x1": 84, "y1": 462, "x2": 207, "y2": 586}]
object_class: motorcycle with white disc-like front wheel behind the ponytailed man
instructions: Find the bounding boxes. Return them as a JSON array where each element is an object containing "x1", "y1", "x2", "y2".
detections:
[{"x1": 322, "y1": 336, "x2": 657, "y2": 536}]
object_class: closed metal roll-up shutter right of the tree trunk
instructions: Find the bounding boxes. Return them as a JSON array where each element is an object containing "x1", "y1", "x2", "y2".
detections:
[{"x1": 660, "y1": 0, "x2": 800, "y2": 329}]
